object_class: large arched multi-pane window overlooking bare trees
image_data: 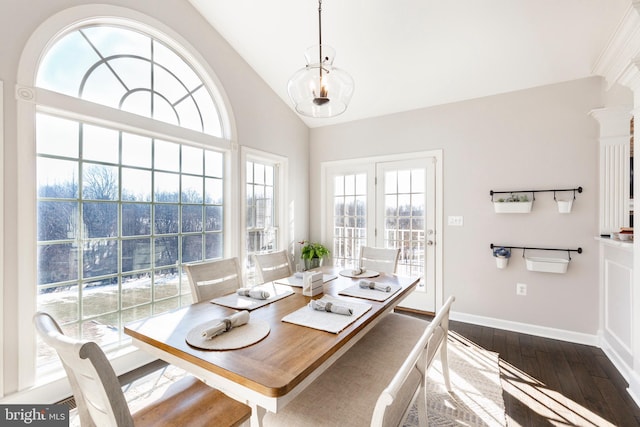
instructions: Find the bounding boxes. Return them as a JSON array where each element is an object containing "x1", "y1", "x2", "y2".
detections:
[{"x1": 35, "y1": 21, "x2": 231, "y2": 366}]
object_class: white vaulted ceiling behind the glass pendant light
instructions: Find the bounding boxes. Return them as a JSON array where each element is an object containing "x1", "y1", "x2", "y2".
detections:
[{"x1": 190, "y1": 0, "x2": 631, "y2": 127}]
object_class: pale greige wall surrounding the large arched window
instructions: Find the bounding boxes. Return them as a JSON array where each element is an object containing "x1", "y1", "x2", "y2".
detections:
[{"x1": 0, "y1": 0, "x2": 309, "y2": 397}]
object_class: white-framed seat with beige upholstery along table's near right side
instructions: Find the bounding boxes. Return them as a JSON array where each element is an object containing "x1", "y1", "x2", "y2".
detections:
[{"x1": 264, "y1": 297, "x2": 455, "y2": 427}]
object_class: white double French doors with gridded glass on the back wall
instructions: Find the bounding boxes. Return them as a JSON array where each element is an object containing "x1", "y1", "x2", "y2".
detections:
[{"x1": 324, "y1": 155, "x2": 442, "y2": 312}]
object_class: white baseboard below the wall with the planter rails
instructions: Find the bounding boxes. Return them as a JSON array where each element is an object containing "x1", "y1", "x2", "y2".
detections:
[{"x1": 449, "y1": 311, "x2": 600, "y2": 347}]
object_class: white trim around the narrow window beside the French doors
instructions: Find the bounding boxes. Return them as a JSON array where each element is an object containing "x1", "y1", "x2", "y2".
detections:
[{"x1": 238, "y1": 146, "x2": 292, "y2": 274}]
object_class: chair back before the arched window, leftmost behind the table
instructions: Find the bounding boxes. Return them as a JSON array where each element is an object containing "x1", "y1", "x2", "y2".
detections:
[{"x1": 184, "y1": 257, "x2": 243, "y2": 303}]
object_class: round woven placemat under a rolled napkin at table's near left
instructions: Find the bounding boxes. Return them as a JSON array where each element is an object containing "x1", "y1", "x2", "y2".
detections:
[{"x1": 186, "y1": 319, "x2": 271, "y2": 350}]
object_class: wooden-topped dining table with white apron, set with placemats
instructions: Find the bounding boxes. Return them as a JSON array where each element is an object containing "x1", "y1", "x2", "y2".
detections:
[{"x1": 124, "y1": 266, "x2": 419, "y2": 426}]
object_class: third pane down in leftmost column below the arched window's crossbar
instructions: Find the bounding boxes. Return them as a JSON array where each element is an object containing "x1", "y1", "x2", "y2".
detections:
[{"x1": 38, "y1": 201, "x2": 80, "y2": 241}]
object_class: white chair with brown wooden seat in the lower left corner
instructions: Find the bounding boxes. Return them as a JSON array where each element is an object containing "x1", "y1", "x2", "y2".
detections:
[{"x1": 33, "y1": 312, "x2": 251, "y2": 427}]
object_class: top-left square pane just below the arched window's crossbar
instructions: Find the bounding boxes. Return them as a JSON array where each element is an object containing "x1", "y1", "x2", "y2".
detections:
[{"x1": 36, "y1": 113, "x2": 80, "y2": 158}]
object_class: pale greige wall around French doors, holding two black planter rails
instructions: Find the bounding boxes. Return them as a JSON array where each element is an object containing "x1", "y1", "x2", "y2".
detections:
[{"x1": 310, "y1": 77, "x2": 603, "y2": 343}]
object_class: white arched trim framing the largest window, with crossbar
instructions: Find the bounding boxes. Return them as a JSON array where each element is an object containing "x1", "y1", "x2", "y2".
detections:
[{"x1": 15, "y1": 5, "x2": 239, "y2": 390}]
